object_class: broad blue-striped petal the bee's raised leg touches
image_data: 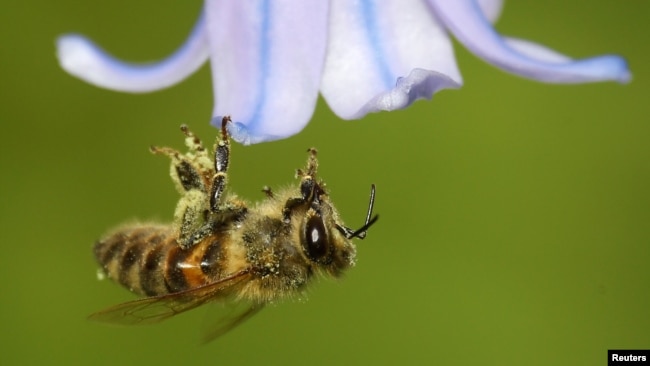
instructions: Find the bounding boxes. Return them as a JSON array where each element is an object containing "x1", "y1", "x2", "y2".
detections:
[{"x1": 206, "y1": 0, "x2": 328, "y2": 144}]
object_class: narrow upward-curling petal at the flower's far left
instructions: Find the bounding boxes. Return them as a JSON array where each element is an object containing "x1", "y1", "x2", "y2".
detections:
[{"x1": 57, "y1": 11, "x2": 208, "y2": 93}]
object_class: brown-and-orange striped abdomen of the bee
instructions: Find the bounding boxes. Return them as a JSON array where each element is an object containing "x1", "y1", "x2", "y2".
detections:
[{"x1": 94, "y1": 225, "x2": 227, "y2": 296}]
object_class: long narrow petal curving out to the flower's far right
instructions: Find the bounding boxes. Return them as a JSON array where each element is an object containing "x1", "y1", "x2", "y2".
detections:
[{"x1": 429, "y1": 0, "x2": 630, "y2": 83}]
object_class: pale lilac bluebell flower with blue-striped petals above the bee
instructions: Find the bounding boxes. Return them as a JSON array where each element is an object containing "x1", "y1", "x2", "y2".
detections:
[{"x1": 57, "y1": 0, "x2": 630, "y2": 144}]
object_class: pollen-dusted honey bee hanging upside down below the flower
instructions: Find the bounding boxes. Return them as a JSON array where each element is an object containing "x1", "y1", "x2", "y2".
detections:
[{"x1": 90, "y1": 116, "x2": 378, "y2": 341}]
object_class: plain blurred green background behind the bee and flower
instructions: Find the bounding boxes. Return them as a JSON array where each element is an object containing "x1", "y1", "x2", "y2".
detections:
[{"x1": 0, "y1": 0, "x2": 650, "y2": 365}]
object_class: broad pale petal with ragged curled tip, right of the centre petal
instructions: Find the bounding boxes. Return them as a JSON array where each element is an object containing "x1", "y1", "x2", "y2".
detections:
[{"x1": 321, "y1": 0, "x2": 462, "y2": 119}]
